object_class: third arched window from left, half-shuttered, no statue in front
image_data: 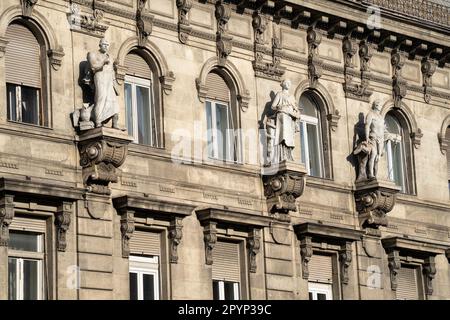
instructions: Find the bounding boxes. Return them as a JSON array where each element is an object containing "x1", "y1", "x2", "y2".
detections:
[{"x1": 205, "y1": 71, "x2": 241, "y2": 162}]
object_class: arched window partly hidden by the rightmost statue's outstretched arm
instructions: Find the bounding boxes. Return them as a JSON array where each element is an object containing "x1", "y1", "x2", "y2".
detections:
[{"x1": 385, "y1": 111, "x2": 414, "y2": 193}]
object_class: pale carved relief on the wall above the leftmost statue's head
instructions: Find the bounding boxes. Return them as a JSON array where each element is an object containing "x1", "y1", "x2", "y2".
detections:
[{"x1": 68, "y1": 3, "x2": 109, "y2": 38}]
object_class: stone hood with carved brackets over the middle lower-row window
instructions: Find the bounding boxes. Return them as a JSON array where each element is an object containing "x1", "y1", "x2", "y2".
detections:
[{"x1": 196, "y1": 207, "x2": 273, "y2": 299}]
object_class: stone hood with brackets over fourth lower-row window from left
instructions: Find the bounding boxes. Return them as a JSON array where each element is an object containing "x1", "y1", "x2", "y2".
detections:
[{"x1": 294, "y1": 222, "x2": 364, "y2": 298}]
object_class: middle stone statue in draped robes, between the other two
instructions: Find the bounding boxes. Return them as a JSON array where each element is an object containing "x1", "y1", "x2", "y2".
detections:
[{"x1": 266, "y1": 80, "x2": 300, "y2": 163}]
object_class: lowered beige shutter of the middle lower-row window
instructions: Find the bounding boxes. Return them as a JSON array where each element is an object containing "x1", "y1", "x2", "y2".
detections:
[{"x1": 212, "y1": 241, "x2": 241, "y2": 282}]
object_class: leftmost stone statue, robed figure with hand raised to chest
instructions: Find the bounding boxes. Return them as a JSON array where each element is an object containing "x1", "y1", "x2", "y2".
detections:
[{"x1": 88, "y1": 38, "x2": 119, "y2": 129}]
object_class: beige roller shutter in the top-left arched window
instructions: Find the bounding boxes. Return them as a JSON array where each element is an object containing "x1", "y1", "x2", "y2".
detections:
[{"x1": 5, "y1": 24, "x2": 42, "y2": 88}]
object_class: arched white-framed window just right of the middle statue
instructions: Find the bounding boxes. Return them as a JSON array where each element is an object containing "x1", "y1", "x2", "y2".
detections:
[{"x1": 300, "y1": 91, "x2": 327, "y2": 178}]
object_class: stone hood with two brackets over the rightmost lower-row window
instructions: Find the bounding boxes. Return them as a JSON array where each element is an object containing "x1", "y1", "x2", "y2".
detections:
[{"x1": 381, "y1": 237, "x2": 450, "y2": 296}]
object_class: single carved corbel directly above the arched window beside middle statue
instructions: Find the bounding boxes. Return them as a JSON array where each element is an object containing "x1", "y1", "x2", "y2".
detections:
[{"x1": 306, "y1": 27, "x2": 323, "y2": 88}]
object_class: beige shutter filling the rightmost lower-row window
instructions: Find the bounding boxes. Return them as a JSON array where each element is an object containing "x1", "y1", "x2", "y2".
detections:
[{"x1": 396, "y1": 264, "x2": 423, "y2": 300}]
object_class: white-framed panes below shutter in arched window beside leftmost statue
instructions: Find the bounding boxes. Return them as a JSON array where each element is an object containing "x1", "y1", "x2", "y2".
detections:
[{"x1": 125, "y1": 76, "x2": 159, "y2": 147}]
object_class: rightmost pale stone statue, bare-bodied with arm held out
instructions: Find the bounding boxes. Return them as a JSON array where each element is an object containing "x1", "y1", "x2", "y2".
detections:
[{"x1": 353, "y1": 100, "x2": 400, "y2": 181}]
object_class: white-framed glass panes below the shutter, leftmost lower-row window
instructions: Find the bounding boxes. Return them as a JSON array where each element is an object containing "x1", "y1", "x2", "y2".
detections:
[{"x1": 8, "y1": 230, "x2": 45, "y2": 300}]
